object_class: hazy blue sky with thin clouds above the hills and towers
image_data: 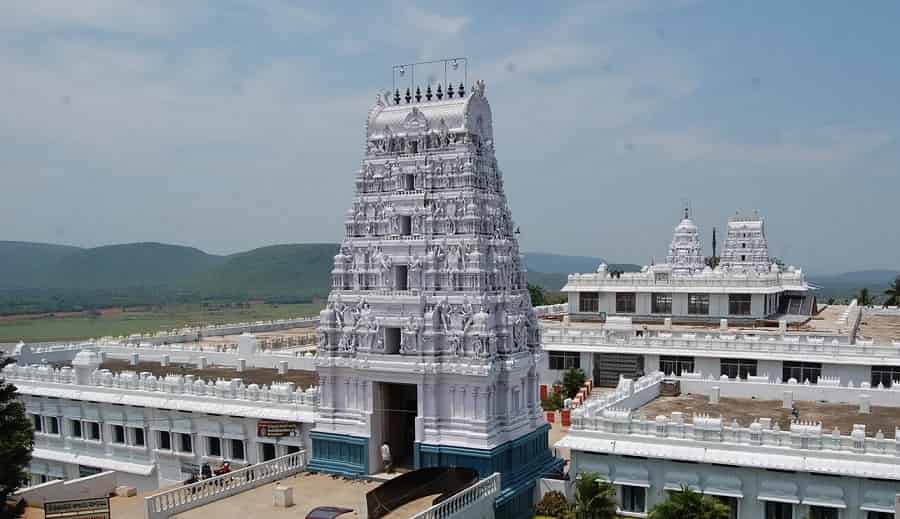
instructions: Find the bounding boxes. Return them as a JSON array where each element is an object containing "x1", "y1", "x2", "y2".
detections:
[{"x1": 0, "y1": 0, "x2": 900, "y2": 273}]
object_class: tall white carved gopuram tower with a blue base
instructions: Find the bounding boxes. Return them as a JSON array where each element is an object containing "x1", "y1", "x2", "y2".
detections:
[{"x1": 309, "y1": 63, "x2": 561, "y2": 517}]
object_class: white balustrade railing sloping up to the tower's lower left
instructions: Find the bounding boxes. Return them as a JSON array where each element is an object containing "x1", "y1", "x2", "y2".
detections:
[{"x1": 144, "y1": 451, "x2": 306, "y2": 519}]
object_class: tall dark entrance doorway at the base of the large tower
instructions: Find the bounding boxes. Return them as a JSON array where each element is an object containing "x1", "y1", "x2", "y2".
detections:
[{"x1": 378, "y1": 382, "x2": 418, "y2": 472}]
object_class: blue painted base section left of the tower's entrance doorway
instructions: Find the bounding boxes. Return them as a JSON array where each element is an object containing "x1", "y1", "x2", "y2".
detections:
[{"x1": 306, "y1": 431, "x2": 369, "y2": 477}]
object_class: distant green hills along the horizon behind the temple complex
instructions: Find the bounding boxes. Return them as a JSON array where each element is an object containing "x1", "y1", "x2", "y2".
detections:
[{"x1": 0, "y1": 241, "x2": 888, "y2": 314}]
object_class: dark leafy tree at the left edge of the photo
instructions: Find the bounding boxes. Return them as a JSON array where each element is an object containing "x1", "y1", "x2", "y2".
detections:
[{"x1": 0, "y1": 356, "x2": 34, "y2": 519}]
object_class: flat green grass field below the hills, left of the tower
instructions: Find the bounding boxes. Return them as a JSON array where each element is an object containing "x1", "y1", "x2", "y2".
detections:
[{"x1": 0, "y1": 304, "x2": 322, "y2": 342}]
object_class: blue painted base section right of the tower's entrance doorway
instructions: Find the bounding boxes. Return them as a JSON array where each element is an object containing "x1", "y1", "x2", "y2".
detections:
[{"x1": 415, "y1": 425, "x2": 563, "y2": 519}]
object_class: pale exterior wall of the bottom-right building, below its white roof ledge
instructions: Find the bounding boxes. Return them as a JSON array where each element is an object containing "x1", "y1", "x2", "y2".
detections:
[{"x1": 570, "y1": 450, "x2": 900, "y2": 519}]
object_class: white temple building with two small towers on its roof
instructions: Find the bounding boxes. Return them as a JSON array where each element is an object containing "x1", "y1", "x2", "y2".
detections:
[{"x1": 562, "y1": 209, "x2": 815, "y2": 323}]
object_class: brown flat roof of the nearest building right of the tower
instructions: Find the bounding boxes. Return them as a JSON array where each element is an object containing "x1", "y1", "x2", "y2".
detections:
[{"x1": 636, "y1": 394, "x2": 900, "y2": 438}]
